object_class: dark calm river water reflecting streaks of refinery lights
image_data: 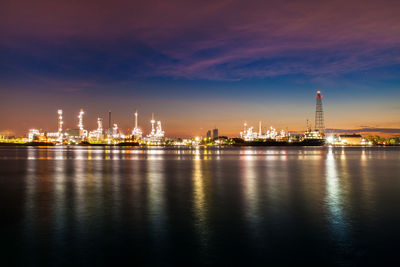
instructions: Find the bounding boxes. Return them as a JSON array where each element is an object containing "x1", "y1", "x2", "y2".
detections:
[{"x1": 0, "y1": 147, "x2": 400, "y2": 266}]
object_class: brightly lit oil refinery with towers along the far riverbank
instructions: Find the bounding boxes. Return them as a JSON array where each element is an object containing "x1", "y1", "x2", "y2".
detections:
[{"x1": 0, "y1": 91, "x2": 392, "y2": 146}]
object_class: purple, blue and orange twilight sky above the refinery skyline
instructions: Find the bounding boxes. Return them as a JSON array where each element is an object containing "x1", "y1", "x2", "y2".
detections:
[{"x1": 0, "y1": 0, "x2": 400, "y2": 137}]
